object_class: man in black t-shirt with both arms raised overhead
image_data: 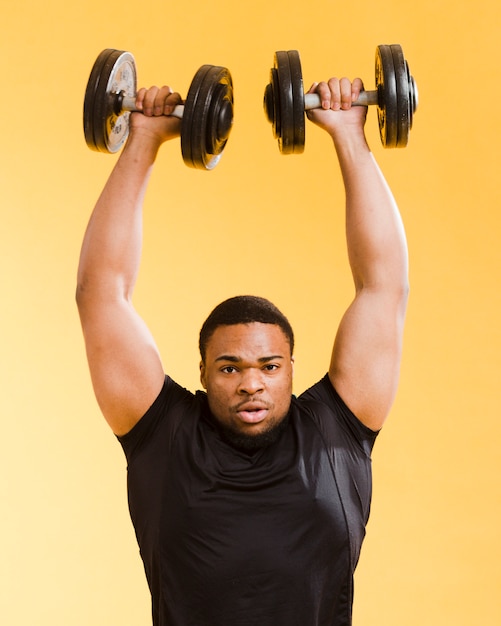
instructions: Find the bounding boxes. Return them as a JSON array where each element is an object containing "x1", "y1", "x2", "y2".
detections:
[{"x1": 77, "y1": 79, "x2": 408, "y2": 626}]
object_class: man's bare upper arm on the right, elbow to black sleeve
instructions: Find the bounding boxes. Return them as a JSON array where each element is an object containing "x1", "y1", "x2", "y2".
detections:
[{"x1": 329, "y1": 289, "x2": 407, "y2": 430}]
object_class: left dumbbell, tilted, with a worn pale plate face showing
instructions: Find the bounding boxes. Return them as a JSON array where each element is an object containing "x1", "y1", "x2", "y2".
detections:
[{"x1": 84, "y1": 48, "x2": 233, "y2": 170}]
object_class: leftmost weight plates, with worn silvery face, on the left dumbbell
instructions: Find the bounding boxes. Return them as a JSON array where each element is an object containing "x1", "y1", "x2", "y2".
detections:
[{"x1": 84, "y1": 48, "x2": 137, "y2": 153}]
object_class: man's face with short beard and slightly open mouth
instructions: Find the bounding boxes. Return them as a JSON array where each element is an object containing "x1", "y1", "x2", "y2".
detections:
[{"x1": 200, "y1": 322, "x2": 294, "y2": 448}]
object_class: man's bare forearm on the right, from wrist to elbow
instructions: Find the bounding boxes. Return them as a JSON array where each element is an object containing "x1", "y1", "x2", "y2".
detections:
[{"x1": 333, "y1": 128, "x2": 407, "y2": 292}]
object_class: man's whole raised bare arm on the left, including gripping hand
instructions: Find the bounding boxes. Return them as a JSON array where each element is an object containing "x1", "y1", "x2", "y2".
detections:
[{"x1": 76, "y1": 87, "x2": 181, "y2": 435}]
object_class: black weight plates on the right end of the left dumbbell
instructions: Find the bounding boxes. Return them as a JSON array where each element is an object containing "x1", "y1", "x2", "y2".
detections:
[{"x1": 181, "y1": 65, "x2": 233, "y2": 170}]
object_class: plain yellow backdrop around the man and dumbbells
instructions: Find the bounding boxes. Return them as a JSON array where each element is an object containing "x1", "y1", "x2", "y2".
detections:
[{"x1": 0, "y1": 0, "x2": 501, "y2": 626}]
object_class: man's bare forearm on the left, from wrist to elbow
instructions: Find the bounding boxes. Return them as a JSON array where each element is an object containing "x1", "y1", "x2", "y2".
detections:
[{"x1": 78, "y1": 130, "x2": 158, "y2": 298}]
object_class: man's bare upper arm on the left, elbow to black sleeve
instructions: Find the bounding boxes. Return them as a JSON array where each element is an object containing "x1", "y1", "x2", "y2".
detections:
[{"x1": 79, "y1": 300, "x2": 164, "y2": 435}]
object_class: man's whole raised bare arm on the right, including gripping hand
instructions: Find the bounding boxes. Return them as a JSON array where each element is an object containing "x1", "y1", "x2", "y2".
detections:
[{"x1": 308, "y1": 79, "x2": 408, "y2": 430}]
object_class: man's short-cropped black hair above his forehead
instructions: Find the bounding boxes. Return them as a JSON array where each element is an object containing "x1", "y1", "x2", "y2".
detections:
[{"x1": 198, "y1": 296, "x2": 294, "y2": 362}]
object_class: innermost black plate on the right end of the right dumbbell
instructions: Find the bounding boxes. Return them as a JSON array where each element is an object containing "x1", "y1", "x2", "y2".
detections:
[{"x1": 376, "y1": 45, "x2": 398, "y2": 148}]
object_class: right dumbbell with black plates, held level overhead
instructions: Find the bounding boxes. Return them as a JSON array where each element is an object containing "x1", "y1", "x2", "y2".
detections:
[{"x1": 264, "y1": 44, "x2": 418, "y2": 154}]
